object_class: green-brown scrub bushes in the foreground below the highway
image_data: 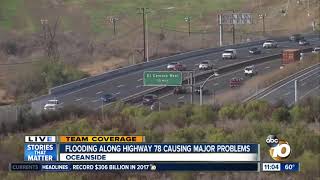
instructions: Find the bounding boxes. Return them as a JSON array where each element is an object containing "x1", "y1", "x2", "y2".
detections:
[{"x1": 0, "y1": 100, "x2": 320, "y2": 180}]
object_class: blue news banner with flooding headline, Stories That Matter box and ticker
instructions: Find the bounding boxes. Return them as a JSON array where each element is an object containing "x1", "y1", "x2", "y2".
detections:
[{"x1": 18, "y1": 143, "x2": 259, "y2": 172}]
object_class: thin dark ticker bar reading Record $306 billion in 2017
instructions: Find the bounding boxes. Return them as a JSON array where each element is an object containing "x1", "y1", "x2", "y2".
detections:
[{"x1": 9, "y1": 162, "x2": 260, "y2": 172}]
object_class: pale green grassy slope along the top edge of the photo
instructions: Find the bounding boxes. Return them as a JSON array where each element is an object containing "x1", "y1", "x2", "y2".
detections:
[{"x1": 0, "y1": 0, "x2": 248, "y2": 33}]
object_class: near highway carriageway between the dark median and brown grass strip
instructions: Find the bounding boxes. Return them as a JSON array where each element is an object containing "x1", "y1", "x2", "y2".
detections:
[{"x1": 160, "y1": 59, "x2": 281, "y2": 104}]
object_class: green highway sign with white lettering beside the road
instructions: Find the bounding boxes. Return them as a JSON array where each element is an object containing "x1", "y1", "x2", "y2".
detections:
[{"x1": 143, "y1": 71, "x2": 182, "y2": 86}]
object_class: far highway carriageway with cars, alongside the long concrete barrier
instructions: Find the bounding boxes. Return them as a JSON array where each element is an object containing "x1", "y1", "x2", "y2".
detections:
[{"x1": 32, "y1": 38, "x2": 320, "y2": 110}]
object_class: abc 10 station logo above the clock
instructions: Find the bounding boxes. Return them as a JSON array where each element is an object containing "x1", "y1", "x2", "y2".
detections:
[{"x1": 266, "y1": 135, "x2": 291, "y2": 161}]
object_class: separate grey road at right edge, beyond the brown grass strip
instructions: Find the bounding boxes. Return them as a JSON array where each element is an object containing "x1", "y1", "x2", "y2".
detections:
[{"x1": 258, "y1": 64, "x2": 320, "y2": 105}]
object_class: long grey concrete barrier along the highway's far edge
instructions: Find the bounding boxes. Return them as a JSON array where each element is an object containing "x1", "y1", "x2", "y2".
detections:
[{"x1": 49, "y1": 35, "x2": 318, "y2": 95}]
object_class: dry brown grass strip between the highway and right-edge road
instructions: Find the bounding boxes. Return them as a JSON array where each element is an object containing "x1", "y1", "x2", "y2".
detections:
[{"x1": 215, "y1": 56, "x2": 320, "y2": 104}]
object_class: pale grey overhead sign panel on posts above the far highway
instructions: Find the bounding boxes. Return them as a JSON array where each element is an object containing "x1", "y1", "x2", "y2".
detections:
[{"x1": 219, "y1": 13, "x2": 252, "y2": 24}]
